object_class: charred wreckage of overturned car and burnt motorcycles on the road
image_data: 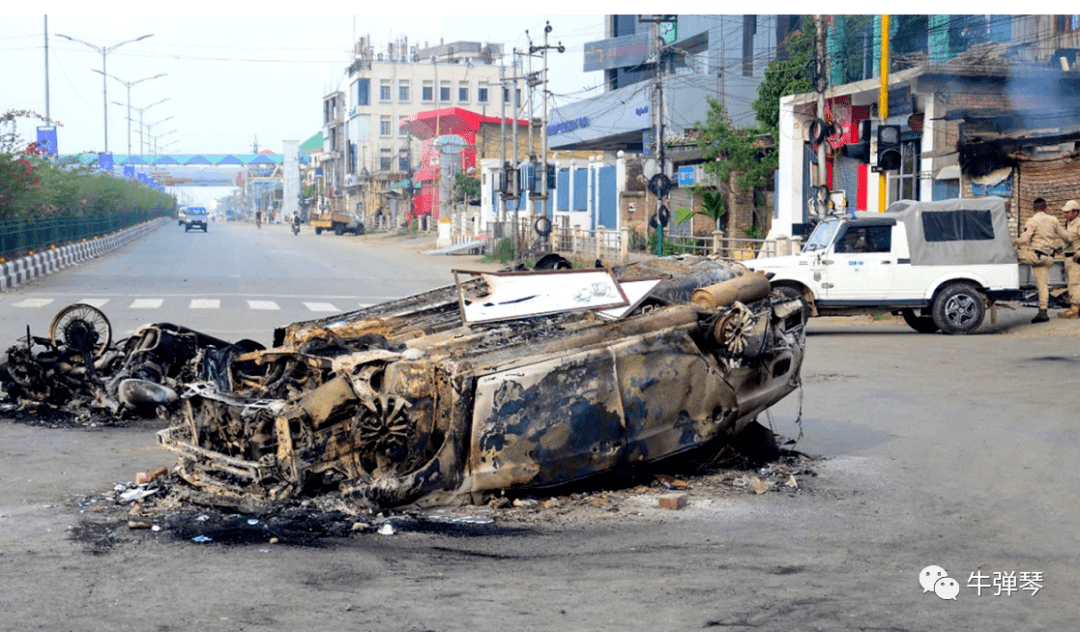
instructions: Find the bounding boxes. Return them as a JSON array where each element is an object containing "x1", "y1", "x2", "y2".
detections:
[{"x1": 2, "y1": 257, "x2": 805, "y2": 508}]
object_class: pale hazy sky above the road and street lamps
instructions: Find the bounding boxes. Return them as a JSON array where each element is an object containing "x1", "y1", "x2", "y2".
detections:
[{"x1": 0, "y1": 7, "x2": 626, "y2": 153}]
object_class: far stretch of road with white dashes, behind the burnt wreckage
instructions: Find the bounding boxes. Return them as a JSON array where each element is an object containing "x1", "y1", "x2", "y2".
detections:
[{"x1": 0, "y1": 223, "x2": 490, "y2": 345}]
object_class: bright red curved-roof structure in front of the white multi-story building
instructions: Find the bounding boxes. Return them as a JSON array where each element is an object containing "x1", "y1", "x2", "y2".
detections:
[{"x1": 401, "y1": 108, "x2": 529, "y2": 220}]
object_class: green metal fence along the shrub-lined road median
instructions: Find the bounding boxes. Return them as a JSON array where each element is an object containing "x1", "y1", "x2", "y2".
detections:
[{"x1": 0, "y1": 211, "x2": 171, "y2": 257}]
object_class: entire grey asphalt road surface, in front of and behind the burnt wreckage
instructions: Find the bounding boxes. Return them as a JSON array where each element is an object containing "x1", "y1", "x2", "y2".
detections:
[{"x1": 0, "y1": 226, "x2": 1080, "y2": 632}]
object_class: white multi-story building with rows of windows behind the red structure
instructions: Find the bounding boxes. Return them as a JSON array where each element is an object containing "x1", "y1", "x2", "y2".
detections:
[{"x1": 323, "y1": 37, "x2": 509, "y2": 224}]
